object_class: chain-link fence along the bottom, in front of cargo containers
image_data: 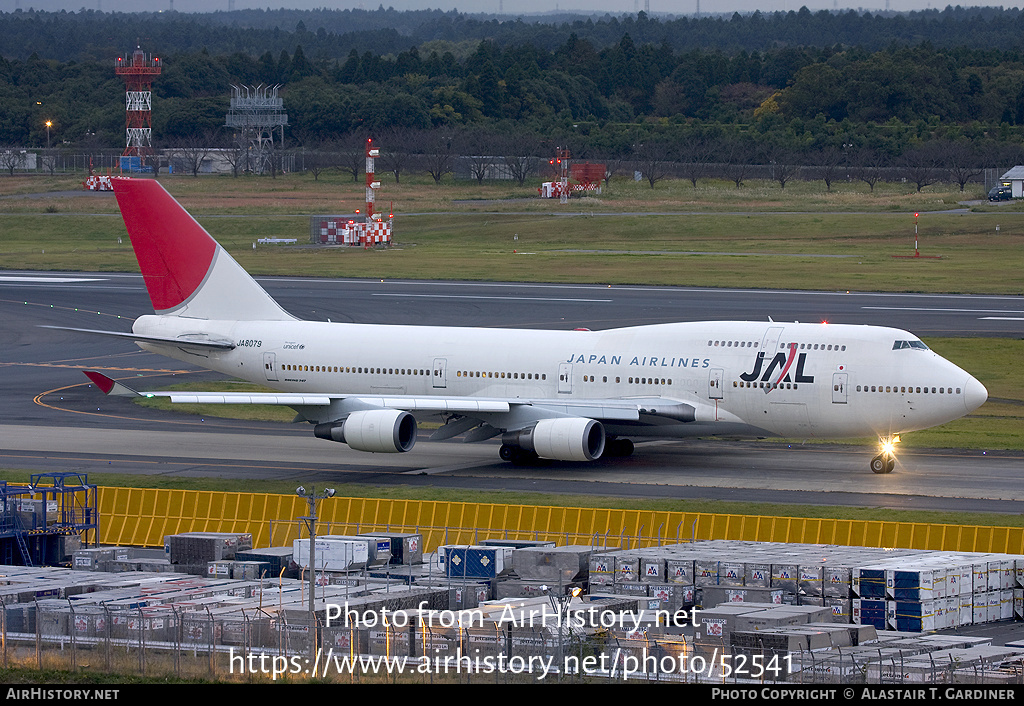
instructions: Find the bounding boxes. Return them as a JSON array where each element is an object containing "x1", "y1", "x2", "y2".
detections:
[{"x1": 6, "y1": 598, "x2": 1024, "y2": 686}]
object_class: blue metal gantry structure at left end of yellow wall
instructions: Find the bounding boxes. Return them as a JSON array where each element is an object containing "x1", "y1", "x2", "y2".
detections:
[{"x1": 0, "y1": 472, "x2": 99, "y2": 567}]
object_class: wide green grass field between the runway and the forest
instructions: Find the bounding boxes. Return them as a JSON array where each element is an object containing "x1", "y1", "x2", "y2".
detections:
[{"x1": 0, "y1": 174, "x2": 1024, "y2": 294}]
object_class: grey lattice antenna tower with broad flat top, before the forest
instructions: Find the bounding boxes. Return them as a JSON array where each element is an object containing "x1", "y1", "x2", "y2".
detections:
[{"x1": 225, "y1": 84, "x2": 288, "y2": 174}]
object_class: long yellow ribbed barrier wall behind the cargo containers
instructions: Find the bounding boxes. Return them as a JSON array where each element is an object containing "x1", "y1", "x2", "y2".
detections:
[{"x1": 99, "y1": 488, "x2": 1024, "y2": 554}]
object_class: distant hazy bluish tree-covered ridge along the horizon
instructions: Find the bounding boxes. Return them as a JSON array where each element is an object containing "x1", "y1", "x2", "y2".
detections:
[{"x1": 6, "y1": 5, "x2": 1024, "y2": 61}]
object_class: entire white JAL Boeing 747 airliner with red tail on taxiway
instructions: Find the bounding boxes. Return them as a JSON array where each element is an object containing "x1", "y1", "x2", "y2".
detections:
[{"x1": 70, "y1": 178, "x2": 988, "y2": 473}]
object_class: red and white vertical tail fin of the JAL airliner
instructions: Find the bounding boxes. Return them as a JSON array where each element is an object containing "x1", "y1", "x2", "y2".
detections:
[{"x1": 111, "y1": 178, "x2": 294, "y2": 321}]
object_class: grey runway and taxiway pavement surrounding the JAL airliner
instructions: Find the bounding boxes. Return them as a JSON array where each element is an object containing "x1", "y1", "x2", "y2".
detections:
[{"x1": 0, "y1": 272, "x2": 1024, "y2": 512}]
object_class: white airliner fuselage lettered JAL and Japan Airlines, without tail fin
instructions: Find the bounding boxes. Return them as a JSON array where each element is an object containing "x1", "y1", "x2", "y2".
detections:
[{"x1": 134, "y1": 316, "x2": 986, "y2": 439}]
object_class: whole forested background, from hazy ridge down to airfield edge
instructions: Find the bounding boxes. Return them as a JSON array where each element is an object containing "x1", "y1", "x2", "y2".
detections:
[{"x1": 6, "y1": 8, "x2": 1024, "y2": 174}]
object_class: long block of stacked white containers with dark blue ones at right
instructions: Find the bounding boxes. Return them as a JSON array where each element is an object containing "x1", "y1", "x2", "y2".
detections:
[{"x1": 590, "y1": 540, "x2": 1024, "y2": 632}]
